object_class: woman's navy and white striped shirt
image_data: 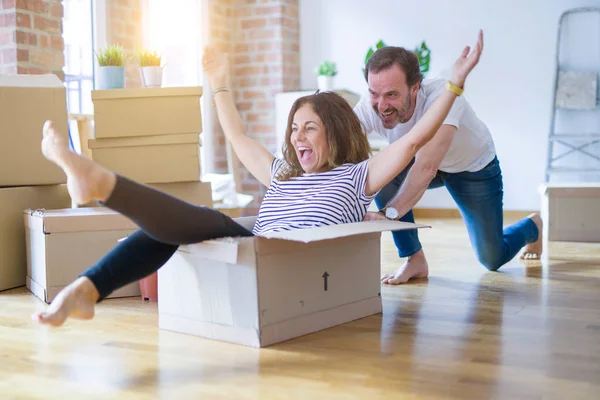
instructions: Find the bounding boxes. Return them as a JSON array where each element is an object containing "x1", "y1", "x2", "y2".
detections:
[{"x1": 252, "y1": 158, "x2": 375, "y2": 234}]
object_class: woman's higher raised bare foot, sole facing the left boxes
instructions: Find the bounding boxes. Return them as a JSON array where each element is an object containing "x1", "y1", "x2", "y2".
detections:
[{"x1": 42, "y1": 121, "x2": 116, "y2": 204}]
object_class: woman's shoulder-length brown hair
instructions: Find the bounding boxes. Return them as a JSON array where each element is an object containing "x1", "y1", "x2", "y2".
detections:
[{"x1": 277, "y1": 91, "x2": 371, "y2": 180}]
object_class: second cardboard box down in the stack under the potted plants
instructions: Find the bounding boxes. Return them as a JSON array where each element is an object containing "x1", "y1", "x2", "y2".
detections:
[{"x1": 88, "y1": 133, "x2": 200, "y2": 183}]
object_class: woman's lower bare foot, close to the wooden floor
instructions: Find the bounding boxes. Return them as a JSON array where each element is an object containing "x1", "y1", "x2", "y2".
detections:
[{"x1": 33, "y1": 277, "x2": 100, "y2": 326}]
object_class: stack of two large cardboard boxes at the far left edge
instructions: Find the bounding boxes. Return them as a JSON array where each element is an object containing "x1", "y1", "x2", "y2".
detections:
[{"x1": 0, "y1": 75, "x2": 70, "y2": 290}]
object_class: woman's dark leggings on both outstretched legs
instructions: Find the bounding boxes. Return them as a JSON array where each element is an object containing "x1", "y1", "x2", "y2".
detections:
[{"x1": 81, "y1": 175, "x2": 252, "y2": 301}]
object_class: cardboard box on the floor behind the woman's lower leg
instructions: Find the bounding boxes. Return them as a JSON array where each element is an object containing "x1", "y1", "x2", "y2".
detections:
[{"x1": 21, "y1": 208, "x2": 140, "y2": 303}]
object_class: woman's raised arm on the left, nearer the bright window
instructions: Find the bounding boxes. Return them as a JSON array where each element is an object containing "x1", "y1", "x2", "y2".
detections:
[{"x1": 202, "y1": 47, "x2": 275, "y2": 186}]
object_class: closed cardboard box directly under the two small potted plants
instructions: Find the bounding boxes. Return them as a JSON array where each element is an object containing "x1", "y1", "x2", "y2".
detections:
[{"x1": 92, "y1": 87, "x2": 202, "y2": 139}]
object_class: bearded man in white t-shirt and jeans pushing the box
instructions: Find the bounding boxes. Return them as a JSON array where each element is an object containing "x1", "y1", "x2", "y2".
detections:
[{"x1": 354, "y1": 43, "x2": 542, "y2": 284}]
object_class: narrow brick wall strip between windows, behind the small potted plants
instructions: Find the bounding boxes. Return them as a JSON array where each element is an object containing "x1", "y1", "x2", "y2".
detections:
[{"x1": 106, "y1": 0, "x2": 142, "y2": 88}]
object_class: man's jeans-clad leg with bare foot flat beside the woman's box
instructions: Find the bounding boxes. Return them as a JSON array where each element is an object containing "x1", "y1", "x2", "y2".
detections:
[{"x1": 375, "y1": 160, "x2": 442, "y2": 285}]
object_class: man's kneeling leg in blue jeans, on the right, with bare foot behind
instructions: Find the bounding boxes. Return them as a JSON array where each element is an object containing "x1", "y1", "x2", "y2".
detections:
[{"x1": 441, "y1": 159, "x2": 542, "y2": 271}]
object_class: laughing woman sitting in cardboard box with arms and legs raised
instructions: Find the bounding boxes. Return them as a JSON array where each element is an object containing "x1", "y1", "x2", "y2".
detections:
[{"x1": 34, "y1": 32, "x2": 483, "y2": 326}]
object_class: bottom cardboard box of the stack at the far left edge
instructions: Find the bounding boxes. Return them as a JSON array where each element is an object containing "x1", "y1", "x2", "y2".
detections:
[{"x1": 0, "y1": 185, "x2": 71, "y2": 290}]
